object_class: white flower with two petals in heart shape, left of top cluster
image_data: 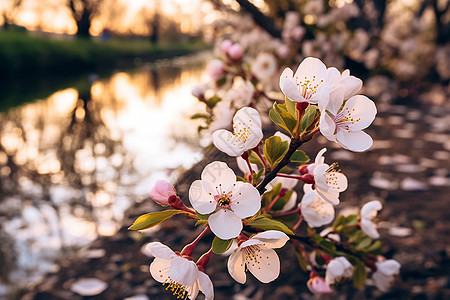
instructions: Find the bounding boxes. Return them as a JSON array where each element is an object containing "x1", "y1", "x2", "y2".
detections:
[{"x1": 212, "y1": 107, "x2": 263, "y2": 156}]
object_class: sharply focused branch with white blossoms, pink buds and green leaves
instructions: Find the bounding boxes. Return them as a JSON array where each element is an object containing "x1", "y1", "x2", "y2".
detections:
[{"x1": 129, "y1": 57, "x2": 400, "y2": 299}]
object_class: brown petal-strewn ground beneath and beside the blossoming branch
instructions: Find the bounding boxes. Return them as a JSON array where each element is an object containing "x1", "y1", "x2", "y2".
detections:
[{"x1": 22, "y1": 99, "x2": 450, "y2": 300}]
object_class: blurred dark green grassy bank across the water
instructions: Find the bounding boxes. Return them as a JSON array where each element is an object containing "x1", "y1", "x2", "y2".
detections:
[{"x1": 0, "y1": 30, "x2": 207, "y2": 78}]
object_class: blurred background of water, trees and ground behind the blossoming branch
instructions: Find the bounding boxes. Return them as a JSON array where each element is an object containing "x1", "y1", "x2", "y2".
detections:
[{"x1": 0, "y1": 0, "x2": 450, "y2": 299}]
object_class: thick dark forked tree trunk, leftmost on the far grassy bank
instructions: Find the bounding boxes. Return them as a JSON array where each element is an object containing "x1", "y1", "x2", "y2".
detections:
[{"x1": 67, "y1": 0, "x2": 103, "y2": 38}]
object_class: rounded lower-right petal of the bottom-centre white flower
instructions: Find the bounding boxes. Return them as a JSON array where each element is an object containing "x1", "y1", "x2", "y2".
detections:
[{"x1": 245, "y1": 247, "x2": 280, "y2": 283}]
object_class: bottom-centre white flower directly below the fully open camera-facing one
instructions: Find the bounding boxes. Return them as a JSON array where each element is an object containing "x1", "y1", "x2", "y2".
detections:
[{"x1": 228, "y1": 230, "x2": 289, "y2": 284}]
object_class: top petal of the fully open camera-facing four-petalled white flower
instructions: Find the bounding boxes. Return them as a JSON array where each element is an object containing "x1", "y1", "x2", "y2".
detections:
[{"x1": 201, "y1": 161, "x2": 236, "y2": 193}]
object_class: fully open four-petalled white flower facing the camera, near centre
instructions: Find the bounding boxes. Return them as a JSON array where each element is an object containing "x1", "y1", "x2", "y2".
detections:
[{"x1": 189, "y1": 161, "x2": 261, "y2": 240}]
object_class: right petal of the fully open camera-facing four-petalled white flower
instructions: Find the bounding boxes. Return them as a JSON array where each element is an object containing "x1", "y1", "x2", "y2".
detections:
[{"x1": 230, "y1": 182, "x2": 261, "y2": 219}]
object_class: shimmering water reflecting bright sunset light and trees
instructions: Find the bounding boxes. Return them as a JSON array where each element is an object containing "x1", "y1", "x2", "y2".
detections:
[{"x1": 0, "y1": 52, "x2": 210, "y2": 296}]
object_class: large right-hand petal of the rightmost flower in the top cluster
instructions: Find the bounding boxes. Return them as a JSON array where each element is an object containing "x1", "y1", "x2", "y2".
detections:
[{"x1": 339, "y1": 95, "x2": 377, "y2": 131}]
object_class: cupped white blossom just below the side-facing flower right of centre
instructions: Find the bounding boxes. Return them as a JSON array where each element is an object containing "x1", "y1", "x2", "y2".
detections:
[{"x1": 301, "y1": 184, "x2": 334, "y2": 227}]
